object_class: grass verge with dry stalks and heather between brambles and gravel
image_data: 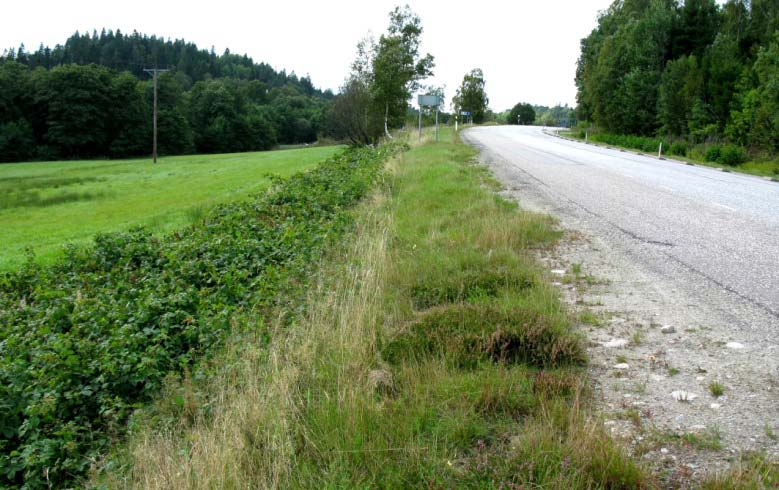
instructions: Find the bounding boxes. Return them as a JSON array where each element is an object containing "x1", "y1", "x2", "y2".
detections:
[{"x1": 95, "y1": 128, "x2": 652, "y2": 488}]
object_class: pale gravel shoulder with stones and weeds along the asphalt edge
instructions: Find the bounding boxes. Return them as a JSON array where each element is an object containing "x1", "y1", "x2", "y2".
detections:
[{"x1": 464, "y1": 128, "x2": 779, "y2": 487}]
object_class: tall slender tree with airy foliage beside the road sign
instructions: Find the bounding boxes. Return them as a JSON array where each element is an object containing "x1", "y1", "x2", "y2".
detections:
[{"x1": 370, "y1": 5, "x2": 434, "y2": 136}]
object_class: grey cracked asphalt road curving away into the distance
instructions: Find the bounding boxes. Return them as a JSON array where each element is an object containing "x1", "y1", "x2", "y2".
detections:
[{"x1": 463, "y1": 126, "x2": 779, "y2": 332}]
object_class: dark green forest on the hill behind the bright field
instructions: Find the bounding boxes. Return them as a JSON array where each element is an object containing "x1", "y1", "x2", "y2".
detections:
[{"x1": 0, "y1": 31, "x2": 333, "y2": 162}]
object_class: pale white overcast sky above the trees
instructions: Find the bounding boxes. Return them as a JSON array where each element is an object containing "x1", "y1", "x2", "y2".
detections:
[{"x1": 0, "y1": 0, "x2": 612, "y2": 112}]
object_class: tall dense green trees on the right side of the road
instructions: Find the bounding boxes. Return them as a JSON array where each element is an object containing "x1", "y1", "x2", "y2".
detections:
[{"x1": 576, "y1": 0, "x2": 779, "y2": 153}]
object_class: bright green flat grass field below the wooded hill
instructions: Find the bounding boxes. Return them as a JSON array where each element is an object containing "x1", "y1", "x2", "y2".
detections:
[{"x1": 0, "y1": 146, "x2": 340, "y2": 271}]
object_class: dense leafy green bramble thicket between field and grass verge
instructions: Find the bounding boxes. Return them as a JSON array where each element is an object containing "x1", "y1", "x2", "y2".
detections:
[{"x1": 0, "y1": 147, "x2": 397, "y2": 488}]
